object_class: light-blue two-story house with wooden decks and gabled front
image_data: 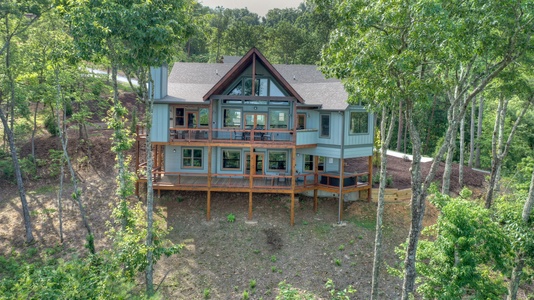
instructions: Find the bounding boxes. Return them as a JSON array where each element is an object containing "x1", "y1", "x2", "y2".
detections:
[{"x1": 137, "y1": 48, "x2": 374, "y2": 225}]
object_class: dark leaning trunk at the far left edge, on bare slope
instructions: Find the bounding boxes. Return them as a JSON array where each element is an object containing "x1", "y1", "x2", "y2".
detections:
[{"x1": 0, "y1": 106, "x2": 34, "y2": 244}]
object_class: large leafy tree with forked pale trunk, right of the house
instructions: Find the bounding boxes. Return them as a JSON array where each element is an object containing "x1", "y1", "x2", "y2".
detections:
[{"x1": 316, "y1": 0, "x2": 533, "y2": 299}]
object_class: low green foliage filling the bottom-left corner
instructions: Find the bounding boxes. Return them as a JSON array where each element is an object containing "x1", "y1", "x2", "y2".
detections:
[{"x1": 0, "y1": 251, "x2": 138, "y2": 299}]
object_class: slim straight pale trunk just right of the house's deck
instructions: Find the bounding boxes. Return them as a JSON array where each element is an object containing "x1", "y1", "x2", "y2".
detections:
[{"x1": 369, "y1": 104, "x2": 401, "y2": 300}]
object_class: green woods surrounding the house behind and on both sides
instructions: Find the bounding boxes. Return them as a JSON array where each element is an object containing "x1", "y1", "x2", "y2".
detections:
[{"x1": 0, "y1": 0, "x2": 534, "y2": 299}]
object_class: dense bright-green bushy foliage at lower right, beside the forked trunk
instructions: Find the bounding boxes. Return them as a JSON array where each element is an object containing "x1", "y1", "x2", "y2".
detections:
[{"x1": 408, "y1": 191, "x2": 511, "y2": 299}]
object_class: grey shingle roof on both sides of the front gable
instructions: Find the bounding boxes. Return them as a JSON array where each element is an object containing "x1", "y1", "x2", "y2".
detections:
[{"x1": 162, "y1": 62, "x2": 348, "y2": 110}]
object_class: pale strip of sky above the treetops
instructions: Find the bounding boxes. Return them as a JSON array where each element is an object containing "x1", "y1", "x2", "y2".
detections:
[{"x1": 198, "y1": 0, "x2": 304, "y2": 17}]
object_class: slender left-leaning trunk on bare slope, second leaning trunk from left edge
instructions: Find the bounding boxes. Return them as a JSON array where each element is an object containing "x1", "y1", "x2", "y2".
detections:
[{"x1": 55, "y1": 69, "x2": 96, "y2": 254}]
